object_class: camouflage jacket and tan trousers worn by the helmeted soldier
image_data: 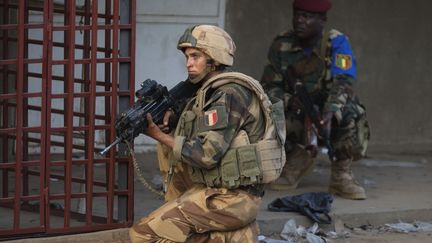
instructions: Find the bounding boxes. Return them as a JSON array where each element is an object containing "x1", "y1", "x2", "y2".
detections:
[{"x1": 130, "y1": 75, "x2": 265, "y2": 242}]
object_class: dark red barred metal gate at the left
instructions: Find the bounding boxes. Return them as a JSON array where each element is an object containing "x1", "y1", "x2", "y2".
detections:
[{"x1": 0, "y1": 0, "x2": 135, "y2": 239}]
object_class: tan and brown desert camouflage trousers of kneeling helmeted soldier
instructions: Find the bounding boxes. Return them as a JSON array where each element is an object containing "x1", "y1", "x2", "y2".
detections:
[{"x1": 129, "y1": 185, "x2": 261, "y2": 242}]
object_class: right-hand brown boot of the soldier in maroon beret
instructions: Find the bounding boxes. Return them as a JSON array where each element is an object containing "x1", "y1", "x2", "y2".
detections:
[{"x1": 329, "y1": 159, "x2": 366, "y2": 200}]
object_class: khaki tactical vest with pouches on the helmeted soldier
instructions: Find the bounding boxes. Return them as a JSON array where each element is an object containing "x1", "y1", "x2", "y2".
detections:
[{"x1": 176, "y1": 72, "x2": 286, "y2": 189}]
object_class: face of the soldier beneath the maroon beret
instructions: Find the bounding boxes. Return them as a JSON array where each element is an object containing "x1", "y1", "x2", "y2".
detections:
[{"x1": 292, "y1": 9, "x2": 325, "y2": 39}]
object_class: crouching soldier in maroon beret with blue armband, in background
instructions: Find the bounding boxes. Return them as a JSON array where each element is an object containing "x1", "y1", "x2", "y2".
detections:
[{"x1": 261, "y1": 0, "x2": 369, "y2": 199}]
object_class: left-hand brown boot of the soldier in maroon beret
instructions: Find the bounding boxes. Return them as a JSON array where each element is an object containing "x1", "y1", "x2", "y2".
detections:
[{"x1": 269, "y1": 146, "x2": 314, "y2": 191}]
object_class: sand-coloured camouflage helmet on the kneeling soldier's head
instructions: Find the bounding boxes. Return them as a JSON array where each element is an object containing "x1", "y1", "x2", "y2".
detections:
[{"x1": 177, "y1": 25, "x2": 236, "y2": 66}]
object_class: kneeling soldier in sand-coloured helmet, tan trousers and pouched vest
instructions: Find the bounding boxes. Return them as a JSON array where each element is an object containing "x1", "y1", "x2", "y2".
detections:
[{"x1": 130, "y1": 25, "x2": 285, "y2": 242}]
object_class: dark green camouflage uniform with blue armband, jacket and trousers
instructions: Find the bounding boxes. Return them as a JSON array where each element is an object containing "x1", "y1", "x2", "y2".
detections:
[{"x1": 261, "y1": 29, "x2": 369, "y2": 199}]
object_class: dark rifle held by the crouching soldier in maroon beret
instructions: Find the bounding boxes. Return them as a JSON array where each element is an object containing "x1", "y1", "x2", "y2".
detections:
[{"x1": 285, "y1": 66, "x2": 335, "y2": 161}]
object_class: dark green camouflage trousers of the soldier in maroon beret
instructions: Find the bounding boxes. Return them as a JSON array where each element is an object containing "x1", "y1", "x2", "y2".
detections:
[{"x1": 285, "y1": 96, "x2": 369, "y2": 160}]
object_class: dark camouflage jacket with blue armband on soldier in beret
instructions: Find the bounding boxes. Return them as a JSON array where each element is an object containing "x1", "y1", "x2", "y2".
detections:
[{"x1": 261, "y1": 30, "x2": 356, "y2": 118}]
